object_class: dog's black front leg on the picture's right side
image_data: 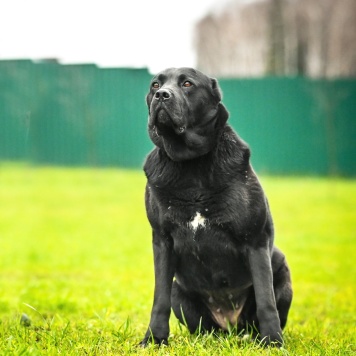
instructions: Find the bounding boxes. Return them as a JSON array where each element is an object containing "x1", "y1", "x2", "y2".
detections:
[{"x1": 249, "y1": 247, "x2": 283, "y2": 346}]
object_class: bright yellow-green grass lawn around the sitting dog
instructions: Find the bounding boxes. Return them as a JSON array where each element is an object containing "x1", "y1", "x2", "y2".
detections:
[{"x1": 0, "y1": 164, "x2": 356, "y2": 355}]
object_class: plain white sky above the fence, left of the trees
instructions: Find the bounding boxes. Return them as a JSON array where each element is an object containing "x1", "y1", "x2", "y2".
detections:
[{"x1": 0, "y1": 0, "x2": 228, "y2": 72}]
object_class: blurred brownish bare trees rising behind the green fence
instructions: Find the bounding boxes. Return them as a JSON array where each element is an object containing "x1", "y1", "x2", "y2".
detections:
[{"x1": 195, "y1": 0, "x2": 356, "y2": 77}]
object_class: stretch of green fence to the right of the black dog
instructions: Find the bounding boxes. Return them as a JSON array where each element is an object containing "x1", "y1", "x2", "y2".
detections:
[{"x1": 220, "y1": 78, "x2": 356, "y2": 175}]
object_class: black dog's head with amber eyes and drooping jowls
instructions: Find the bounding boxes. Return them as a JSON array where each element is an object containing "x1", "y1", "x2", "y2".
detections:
[{"x1": 146, "y1": 68, "x2": 229, "y2": 161}]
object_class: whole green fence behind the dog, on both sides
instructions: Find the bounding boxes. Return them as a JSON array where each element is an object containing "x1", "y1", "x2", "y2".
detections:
[{"x1": 0, "y1": 60, "x2": 356, "y2": 176}]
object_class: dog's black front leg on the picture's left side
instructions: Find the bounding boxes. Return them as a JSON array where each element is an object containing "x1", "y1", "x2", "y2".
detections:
[{"x1": 140, "y1": 231, "x2": 175, "y2": 346}]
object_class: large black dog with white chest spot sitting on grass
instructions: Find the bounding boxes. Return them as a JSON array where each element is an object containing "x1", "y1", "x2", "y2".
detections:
[{"x1": 141, "y1": 68, "x2": 292, "y2": 346}]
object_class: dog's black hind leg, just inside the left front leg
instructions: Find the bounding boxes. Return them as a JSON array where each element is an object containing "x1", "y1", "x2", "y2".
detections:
[{"x1": 171, "y1": 281, "x2": 220, "y2": 334}]
